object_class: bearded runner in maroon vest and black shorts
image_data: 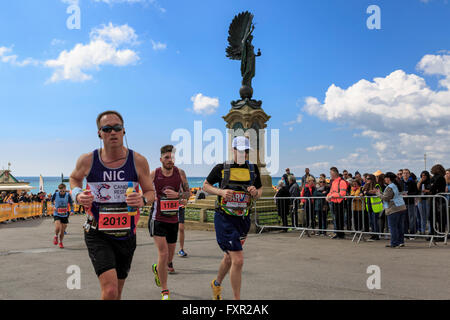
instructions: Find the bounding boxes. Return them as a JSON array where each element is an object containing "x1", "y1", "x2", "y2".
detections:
[{"x1": 148, "y1": 145, "x2": 190, "y2": 300}]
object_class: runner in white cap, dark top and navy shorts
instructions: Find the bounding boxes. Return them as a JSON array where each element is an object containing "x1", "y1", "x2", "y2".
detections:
[{"x1": 203, "y1": 136, "x2": 262, "y2": 300}]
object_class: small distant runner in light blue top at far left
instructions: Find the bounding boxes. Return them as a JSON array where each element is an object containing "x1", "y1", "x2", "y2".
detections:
[{"x1": 52, "y1": 183, "x2": 73, "y2": 249}]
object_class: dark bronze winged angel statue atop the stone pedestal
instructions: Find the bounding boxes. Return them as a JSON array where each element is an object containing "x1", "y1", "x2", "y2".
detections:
[{"x1": 226, "y1": 11, "x2": 262, "y2": 108}]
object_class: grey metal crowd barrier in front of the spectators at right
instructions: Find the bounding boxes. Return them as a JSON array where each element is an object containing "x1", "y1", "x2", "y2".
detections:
[{"x1": 253, "y1": 193, "x2": 450, "y2": 247}]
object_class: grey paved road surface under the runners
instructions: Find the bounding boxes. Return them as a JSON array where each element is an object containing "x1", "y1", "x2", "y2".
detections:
[{"x1": 0, "y1": 216, "x2": 450, "y2": 300}]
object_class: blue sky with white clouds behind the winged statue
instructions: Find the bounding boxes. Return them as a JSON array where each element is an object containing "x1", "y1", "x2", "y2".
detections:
[{"x1": 0, "y1": 0, "x2": 450, "y2": 176}]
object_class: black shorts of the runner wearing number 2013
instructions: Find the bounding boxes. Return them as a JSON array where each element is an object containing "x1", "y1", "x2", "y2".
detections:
[{"x1": 84, "y1": 229, "x2": 136, "y2": 279}]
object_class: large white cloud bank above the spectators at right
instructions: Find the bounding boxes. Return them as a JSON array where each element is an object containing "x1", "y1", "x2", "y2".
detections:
[{"x1": 303, "y1": 54, "x2": 450, "y2": 165}]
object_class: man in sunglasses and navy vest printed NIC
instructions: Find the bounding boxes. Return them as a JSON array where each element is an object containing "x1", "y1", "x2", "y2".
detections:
[{"x1": 70, "y1": 111, "x2": 154, "y2": 300}]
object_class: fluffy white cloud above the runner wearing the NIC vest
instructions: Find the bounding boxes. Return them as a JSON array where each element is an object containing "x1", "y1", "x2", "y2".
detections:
[{"x1": 45, "y1": 23, "x2": 139, "y2": 82}]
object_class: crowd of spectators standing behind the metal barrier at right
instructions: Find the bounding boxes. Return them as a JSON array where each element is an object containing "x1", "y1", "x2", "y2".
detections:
[{"x1": 275, "y1": 164, "x2": 450, "y2": 246}]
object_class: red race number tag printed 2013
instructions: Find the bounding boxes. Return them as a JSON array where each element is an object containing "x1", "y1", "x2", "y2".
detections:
[{"x1": 98, "y1": 207, "x2": 131, "y2": 231}]
